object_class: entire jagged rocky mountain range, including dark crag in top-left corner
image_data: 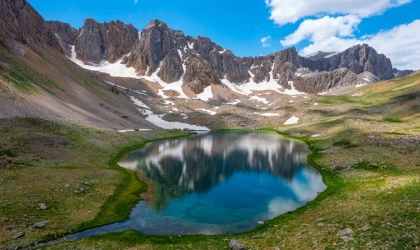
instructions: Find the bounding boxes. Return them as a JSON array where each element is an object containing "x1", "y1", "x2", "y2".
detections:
[{"x1": 0, "y1": 0, "x2": 406, "y2": 101}]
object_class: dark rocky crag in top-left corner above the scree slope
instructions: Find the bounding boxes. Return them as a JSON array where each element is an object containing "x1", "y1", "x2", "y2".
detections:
[{"x1": 0, "y1": 0, "x2": 62, "y2": 54}]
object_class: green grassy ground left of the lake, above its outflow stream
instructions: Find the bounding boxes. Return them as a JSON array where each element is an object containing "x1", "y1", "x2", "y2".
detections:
[{"x1": 0, "y1": 118, "x2": 190, "y2": 249}]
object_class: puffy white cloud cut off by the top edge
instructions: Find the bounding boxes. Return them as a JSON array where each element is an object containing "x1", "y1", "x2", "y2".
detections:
[{"x1": 265, "y1": 0, "x2": 412, "y2": 25}]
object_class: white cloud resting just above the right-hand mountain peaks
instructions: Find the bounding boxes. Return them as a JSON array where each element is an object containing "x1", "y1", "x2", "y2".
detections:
[{"x1": 296, "y1": 20, "x2": 420, "y2": 70}]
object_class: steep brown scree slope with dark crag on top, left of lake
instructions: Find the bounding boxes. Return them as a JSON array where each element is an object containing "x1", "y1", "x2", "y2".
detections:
[{"x1": 0, "y1": 0, "x2": 156, "y2": 129}]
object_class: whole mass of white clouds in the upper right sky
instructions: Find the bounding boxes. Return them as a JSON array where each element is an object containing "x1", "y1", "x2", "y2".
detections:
[{"x1": 265, "y1": 0, "x2": 420, "y2": 69}]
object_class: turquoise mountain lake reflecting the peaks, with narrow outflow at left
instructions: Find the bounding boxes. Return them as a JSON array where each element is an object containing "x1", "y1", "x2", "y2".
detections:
[{"x1": 69, "y1": 132, "x2": 326, "y2": 238}]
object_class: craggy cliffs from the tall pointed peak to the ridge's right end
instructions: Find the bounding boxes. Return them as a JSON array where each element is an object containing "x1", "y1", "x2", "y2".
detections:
[{"x1": 123, "y1": 20, "x2": 393, "y2": 93}]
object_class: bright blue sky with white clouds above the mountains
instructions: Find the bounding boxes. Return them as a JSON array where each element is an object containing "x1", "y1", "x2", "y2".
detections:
[{"x1": 28, "y1": 0, "x2": 420, "y2": 70}]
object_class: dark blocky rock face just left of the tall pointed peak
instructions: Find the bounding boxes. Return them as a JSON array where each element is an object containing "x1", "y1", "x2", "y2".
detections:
[{"x1": 76, "y1": 19, "x2": 138, "y2": 63}]
